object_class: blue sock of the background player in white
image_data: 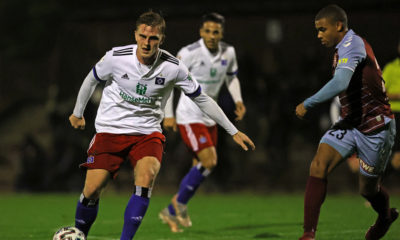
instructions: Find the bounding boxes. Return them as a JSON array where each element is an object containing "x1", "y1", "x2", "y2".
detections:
[{"x1": 177, "y1": 163, "x2": 210, "y2": 204}]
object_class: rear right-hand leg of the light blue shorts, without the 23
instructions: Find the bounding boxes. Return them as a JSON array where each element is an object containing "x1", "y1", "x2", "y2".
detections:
[{"x1": 354, "y1": 120, "x2": 396, "y2": 178}]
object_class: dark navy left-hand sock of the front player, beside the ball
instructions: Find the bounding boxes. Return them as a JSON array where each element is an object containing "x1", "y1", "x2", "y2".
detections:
[{"x1": 75, "y1": 193, "x2": 99, "y2": 236}]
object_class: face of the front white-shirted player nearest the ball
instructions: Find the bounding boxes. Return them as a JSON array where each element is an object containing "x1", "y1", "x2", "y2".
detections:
[{"x1": 135, "y1": 24, "x2": 164, "y2": 64}]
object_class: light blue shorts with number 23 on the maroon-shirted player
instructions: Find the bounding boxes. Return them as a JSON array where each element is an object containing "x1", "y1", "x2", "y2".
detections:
[{"x1": 320, "y1": 119, "x2": 396, "y2": 177}]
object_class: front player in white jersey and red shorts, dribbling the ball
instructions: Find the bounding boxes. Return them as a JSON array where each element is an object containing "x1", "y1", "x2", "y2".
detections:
[{"x1": 69, "y1": 11, "x2": 255, "y2": 240}]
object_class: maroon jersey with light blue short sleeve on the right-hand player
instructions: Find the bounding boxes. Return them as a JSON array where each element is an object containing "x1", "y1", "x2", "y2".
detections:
[{"x1": 333, "y1": 30, "x2": 393, "y2": 133}]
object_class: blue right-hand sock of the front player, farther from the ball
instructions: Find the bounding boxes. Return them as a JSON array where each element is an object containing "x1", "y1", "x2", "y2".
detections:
[{"x1": 120, "y1": 186, "x2": 151, "y2": 240}]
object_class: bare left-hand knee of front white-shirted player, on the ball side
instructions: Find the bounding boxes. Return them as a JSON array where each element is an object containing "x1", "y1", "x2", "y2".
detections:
[{"x1": 83, "y1": 169, "x2": 111, "y2": 199}]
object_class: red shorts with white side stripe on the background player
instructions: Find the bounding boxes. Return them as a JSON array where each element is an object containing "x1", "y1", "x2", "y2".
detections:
[{"x1": 178, "y1": 123, "x2": 218, "y2": 153}]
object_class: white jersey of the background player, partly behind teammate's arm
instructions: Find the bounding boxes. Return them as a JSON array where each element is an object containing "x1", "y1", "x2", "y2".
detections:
[{"x1": 176, "y1": 39, "x2": 238, "y2": 126}]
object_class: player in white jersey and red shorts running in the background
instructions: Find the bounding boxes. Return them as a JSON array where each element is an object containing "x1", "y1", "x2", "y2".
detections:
[{"x1": 159, "y1": 13, "x2": 246, "y2": 232}]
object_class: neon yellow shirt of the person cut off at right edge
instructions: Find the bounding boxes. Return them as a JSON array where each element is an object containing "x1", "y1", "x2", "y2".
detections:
[{"x1": 382, "y1": 57, "x2": 400, "y2": 113}]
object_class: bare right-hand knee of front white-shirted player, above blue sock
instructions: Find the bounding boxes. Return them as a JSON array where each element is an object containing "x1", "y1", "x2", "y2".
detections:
[{"x1": 134, "y1": 156, "x2": 161, "y2": 188}]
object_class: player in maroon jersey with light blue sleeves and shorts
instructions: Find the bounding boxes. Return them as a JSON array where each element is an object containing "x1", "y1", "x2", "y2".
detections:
[{"x1": 296, "y1": 5, "x2": 399, "y2": 240}]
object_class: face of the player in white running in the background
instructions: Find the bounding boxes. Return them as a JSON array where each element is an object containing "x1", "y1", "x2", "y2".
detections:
[{"x1": 200, "y1": 21, "x2": 223, "y2": 52}]
